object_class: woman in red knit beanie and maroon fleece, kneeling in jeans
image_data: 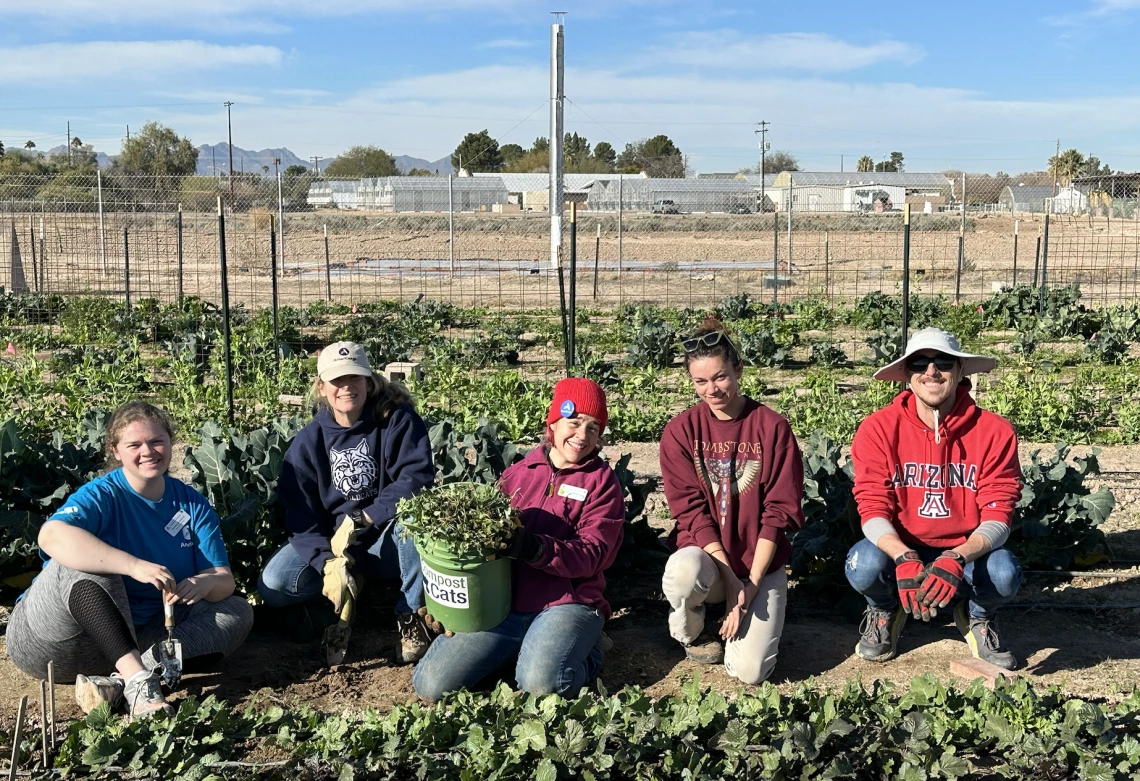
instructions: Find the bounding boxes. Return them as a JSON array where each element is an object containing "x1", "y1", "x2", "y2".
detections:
[{"x1": 412, "y1": 377, "x2": 625, "y2": 702}]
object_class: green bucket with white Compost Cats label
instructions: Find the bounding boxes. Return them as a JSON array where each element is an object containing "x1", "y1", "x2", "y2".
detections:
[{"x1": 415, "y1": 539, "x2": 511, "y2": 632}]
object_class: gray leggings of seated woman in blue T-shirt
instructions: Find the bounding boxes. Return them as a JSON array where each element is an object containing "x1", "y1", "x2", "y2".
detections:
[{"x1": 7, "y1": 561, "x2": 253, "y2": 683}]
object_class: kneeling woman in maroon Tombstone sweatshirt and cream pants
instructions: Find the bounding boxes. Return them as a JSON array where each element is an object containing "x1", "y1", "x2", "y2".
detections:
[{"x1": 660, "y1": 317, "x2": 804, "y2": 684}]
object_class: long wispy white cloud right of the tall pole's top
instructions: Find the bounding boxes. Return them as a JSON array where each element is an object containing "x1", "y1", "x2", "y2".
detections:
[{"x1": 656, "y1": 30, "x2": 923, "y2": 72}]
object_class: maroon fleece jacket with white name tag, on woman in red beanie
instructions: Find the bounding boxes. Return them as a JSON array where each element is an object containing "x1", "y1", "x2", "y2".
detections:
[{"x1": 499, "y1": 446, "x2": 626, "y2": 618}]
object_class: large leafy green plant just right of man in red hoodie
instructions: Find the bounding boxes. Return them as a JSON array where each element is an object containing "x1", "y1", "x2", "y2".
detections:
[{"x1": 1009, "y1": 445, "x2": 1116, "y2": 569}]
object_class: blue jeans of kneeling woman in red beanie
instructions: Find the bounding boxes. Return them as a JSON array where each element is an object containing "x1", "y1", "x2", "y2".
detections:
[{"x1": 412, "y1": 604, "x2": 605, "y2": 702}]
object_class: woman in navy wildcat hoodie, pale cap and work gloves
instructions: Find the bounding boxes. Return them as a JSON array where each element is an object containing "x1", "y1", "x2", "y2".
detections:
[{"x1": 258, "y1": 342, "x2": 435, "y2": 664}]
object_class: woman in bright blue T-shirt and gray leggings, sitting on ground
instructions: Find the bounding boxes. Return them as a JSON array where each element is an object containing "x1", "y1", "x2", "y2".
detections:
[{"x1": 7, "y1": 401, "x2": 253, "y2": 718}]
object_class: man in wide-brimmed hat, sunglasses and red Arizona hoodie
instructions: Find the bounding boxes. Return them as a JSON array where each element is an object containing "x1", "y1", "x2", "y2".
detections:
[{"x1": 845, "y1": 328, "x2": 1021, "y2": 669}]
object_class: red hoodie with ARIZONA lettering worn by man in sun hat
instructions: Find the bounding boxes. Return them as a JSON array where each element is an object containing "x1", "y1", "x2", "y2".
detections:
[{"x1": 852, "y1": 380, "x2": 1021, "y2": 550}]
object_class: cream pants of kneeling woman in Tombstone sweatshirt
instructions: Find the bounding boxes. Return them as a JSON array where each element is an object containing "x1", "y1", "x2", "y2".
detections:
[{"x1": 661, "y1": 547, "x2": 788, "y2": 684}]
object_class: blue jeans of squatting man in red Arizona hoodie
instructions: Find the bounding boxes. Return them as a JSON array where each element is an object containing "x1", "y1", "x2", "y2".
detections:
[{"x1": 844, "y1": 539, "x2": 1021, "y2": 618}]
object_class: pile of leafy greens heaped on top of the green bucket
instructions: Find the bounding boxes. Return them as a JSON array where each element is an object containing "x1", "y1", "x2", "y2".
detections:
[{"x1": 397, "y1": 482, "x2": 520, "y2": 558}]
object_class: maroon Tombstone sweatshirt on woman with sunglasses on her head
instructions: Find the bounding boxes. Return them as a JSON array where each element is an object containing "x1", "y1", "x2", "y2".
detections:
[{"x1": 660, "y1": 399, "x2": 804, "y2": 578}]
